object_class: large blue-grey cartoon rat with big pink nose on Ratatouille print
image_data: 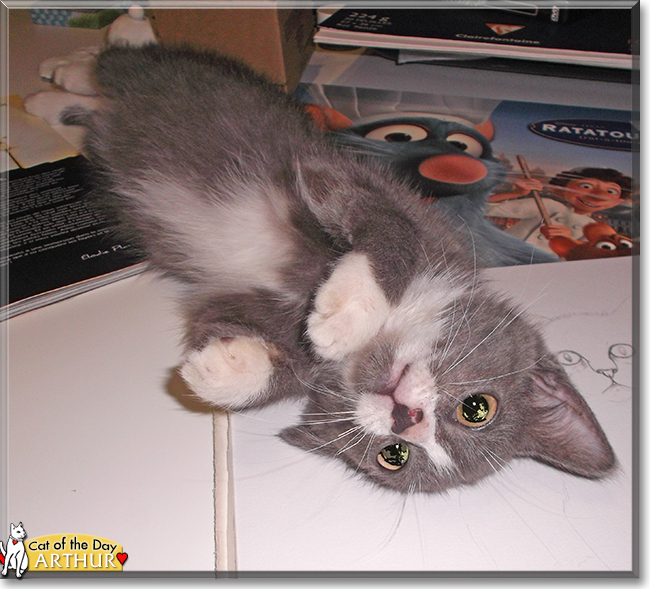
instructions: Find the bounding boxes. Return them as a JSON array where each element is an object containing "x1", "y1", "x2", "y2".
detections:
[{"x1": 307, "y1": 104, "x2": 558, "y2": 266}]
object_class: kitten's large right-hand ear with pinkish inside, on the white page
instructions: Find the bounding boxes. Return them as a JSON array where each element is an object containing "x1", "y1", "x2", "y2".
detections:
[{"x1": 521, "y1": 358, "x2": 616, "y2": 478}]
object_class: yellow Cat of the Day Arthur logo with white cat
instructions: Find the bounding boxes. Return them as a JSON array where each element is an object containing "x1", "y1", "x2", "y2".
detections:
[{"x1": 0, "y1": 522, "x2": 129, "y2": 578}]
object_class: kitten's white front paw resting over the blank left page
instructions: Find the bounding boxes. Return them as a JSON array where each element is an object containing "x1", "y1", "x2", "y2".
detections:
[{"x1": 180, "y1": 336, "x2": 273, "y2": 409}]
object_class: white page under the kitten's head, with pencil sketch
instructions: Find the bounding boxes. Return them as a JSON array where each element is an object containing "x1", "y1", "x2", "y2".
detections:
[{"x1": 231, "y1": 257, "x2": 633, "y2": 572}]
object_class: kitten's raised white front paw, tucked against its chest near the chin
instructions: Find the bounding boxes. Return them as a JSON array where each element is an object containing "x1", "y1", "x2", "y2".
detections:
[{"x1": 307, "y1": 252, "x2": 390, "y2": 360}]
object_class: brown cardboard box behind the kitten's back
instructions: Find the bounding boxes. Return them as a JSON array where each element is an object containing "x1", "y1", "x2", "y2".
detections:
[{"x1": 147, "y1": 8, "x2": 316, "y2": 92}]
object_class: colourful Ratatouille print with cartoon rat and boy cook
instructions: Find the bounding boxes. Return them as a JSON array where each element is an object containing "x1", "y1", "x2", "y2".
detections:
[{"x1": 296, "y1": 84, "x2": 640, "y2": 266}]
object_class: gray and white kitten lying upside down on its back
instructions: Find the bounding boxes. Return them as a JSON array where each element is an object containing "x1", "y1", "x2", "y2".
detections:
[{"x1": 74, "y1": 45, "x2": 616, "y2": 492}]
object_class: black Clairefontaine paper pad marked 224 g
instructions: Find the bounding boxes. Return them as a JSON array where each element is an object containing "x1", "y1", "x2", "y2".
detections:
[{"x1": 315, "y1": 3, "x2": 638, "y2": 69}]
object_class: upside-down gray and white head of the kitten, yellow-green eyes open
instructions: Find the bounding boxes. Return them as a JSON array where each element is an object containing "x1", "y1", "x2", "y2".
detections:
[{"x1": 281, "y1": 279, "x2": 616, "y2": 493}]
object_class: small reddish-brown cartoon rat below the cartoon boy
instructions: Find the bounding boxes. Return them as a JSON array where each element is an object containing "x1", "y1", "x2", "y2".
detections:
[{"x1": 549, "y1": 223, "x2": 638, "y2": 260}]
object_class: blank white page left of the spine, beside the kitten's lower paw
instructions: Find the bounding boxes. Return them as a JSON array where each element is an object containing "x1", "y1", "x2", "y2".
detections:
[{"x1": 6, "y1": 274, "x2": 215, "y2": 574}]
